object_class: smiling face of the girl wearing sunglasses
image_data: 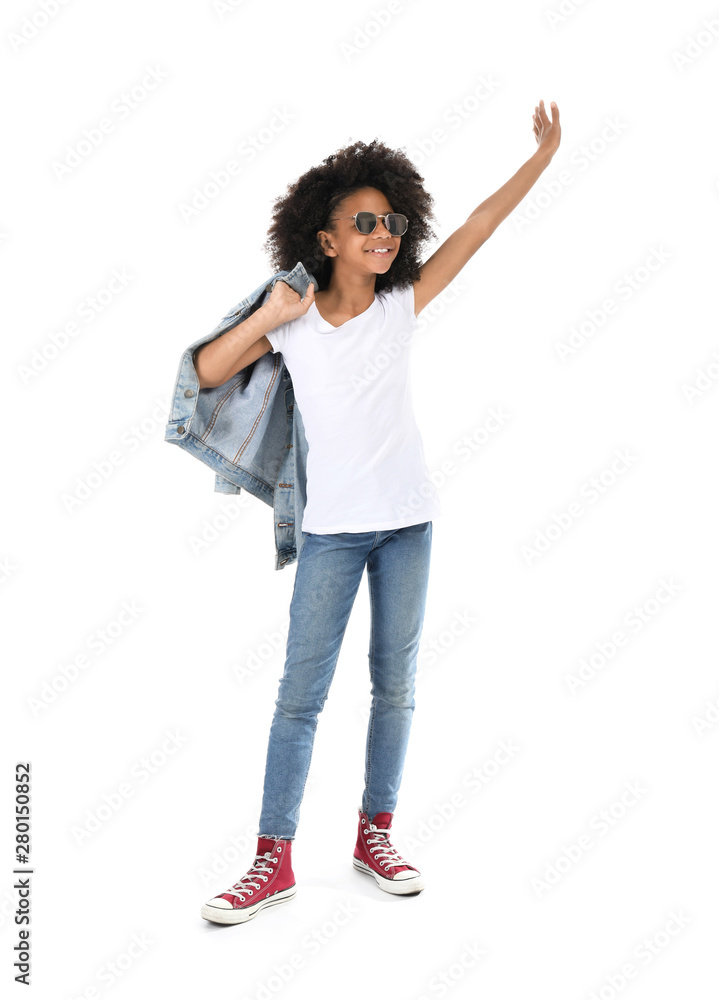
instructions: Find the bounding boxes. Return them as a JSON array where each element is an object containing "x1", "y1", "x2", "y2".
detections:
[{"x1": 317, "y1": 187, "x2": 402, "y2": 276}]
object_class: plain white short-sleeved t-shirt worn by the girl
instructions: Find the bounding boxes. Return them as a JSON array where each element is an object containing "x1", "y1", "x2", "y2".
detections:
[{"x1": 267, "y1": 285, "x2": 442, "y2": 534}]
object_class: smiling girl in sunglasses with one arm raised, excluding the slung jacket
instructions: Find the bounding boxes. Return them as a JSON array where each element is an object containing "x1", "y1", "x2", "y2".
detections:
[{"x1": 195, "y1": 101, "x2": 560, "y2": 924}]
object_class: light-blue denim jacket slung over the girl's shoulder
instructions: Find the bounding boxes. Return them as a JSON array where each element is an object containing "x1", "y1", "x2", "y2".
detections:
[{"x1": 165, "y1": 261, "x2": 317, "y2": 570}]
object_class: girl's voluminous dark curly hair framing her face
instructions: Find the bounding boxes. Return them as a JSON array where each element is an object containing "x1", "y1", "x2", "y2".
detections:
[{"x1": 262, "y1": 139, "x2": 436, "y2": 292}]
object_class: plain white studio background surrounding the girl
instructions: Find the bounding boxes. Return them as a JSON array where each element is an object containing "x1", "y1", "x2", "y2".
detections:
[{"x1": 0, "y1": 0, "x2": 719, "y2": 1000}]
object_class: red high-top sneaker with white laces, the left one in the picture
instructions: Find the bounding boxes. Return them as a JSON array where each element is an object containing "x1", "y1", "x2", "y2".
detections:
[{"x1": 201, "y1": 837, "x2": 297, "y2": 924}]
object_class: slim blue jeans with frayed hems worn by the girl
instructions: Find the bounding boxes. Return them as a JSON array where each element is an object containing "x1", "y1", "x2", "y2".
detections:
[{"x1": 258, "y1": 521, "x2": 432, "y2": 840}]
